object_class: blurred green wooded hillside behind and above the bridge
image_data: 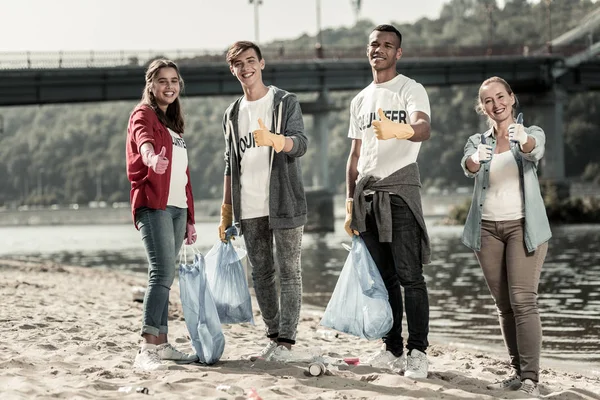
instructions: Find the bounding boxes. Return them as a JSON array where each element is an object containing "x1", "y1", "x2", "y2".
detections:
[{"x1": 0, "y1": 0, "x2": 600, "y2": 206}]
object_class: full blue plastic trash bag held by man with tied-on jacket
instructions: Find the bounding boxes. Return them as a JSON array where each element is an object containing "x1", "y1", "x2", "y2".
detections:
[{"x1": 321, "y1": 236, "x2": 394, "y2": 340}]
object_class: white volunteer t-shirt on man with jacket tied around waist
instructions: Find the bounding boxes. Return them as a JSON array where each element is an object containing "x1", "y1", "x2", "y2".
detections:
[{"x1": 348, "y1": 75, "x2": 431, "y2": 180}]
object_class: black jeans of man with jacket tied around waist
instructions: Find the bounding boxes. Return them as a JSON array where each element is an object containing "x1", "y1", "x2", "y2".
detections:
[{"x1": 360, "y1": 195, "x2": 429, "y2": 357}]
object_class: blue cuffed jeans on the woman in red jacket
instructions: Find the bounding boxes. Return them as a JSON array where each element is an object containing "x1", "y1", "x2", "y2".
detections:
[{"x1": 135, "y1": 206, "x2": 187, "y2": 336}]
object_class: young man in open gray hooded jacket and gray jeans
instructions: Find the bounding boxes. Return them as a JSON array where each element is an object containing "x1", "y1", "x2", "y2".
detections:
[{"x1": 219, "y1": 41, "x2": 308, "y2": 360}]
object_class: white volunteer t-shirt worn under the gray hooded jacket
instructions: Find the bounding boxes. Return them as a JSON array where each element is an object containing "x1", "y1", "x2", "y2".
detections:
[{"x1": 238, "y1": 88, "x2": 275, "y2": 219}]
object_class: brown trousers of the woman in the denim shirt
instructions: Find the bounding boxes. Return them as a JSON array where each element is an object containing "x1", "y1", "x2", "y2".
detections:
[{"x1": 475, "y1": 219, "x2": 548, "y2": 382}]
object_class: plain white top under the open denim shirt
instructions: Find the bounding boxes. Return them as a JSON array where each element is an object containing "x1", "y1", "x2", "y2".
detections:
[{"x1": 481, "y1": 151, "x2": 525, "y2": 221}]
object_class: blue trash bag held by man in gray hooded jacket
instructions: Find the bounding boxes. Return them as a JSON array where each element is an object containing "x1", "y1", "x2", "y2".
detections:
[{"x1": 205, "y1": 227, "x2": 254, "y2": 324}]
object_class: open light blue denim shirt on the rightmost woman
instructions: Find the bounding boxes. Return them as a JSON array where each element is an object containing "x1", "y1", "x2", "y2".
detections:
[{"x1": 460, "y1": 125, "x2": 552, "y2": 252}]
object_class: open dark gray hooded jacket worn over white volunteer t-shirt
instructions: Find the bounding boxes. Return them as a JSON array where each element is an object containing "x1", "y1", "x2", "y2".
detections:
[{"x1": 223, "y1": 86, "x2": 308, "y2": 235}]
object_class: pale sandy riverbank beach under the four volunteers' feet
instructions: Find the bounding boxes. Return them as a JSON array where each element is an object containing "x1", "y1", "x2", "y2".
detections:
[{"x1": 0, "y1": 260, "x2": 600, "y2": 400}]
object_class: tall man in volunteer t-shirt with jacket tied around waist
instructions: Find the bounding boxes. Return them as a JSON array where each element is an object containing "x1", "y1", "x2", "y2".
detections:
[{"x1": 344, "y1": 25, "x2": 431, "y2": 378}]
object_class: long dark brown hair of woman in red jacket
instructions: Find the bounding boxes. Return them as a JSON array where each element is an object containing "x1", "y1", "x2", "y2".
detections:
[{"x1": 138, "y1": 58, "x2": 185, "y2": 134}]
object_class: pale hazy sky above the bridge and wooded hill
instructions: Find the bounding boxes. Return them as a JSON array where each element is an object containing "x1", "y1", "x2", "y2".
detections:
[{"x1": 0, "y1": 0, "x2": 449, "y2": 52}]
